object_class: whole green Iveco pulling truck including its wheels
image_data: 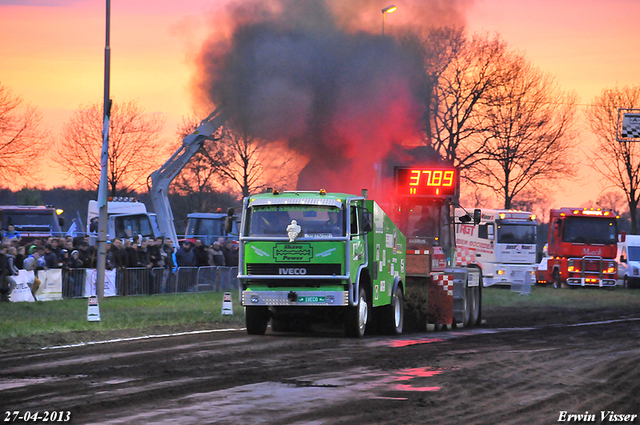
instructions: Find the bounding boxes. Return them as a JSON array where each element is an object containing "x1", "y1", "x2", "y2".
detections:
[{"x1": 238, "y1": 190, "x2": 406, "y2": 337}]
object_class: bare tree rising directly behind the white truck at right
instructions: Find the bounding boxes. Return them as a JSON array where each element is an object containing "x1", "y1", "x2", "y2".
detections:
[{"x1": 469, "y1": 55, "x2": 577, "y2": 208}]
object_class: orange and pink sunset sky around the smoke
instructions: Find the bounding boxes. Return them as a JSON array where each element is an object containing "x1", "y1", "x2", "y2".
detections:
[{"x1": 0, "y1": 0, "x2": 640, "y2": 207}]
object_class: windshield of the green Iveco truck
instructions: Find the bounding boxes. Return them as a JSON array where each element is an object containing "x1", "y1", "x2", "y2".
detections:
[{"x1": 248, "y1": 205, "x2": 344, "y2": 238}]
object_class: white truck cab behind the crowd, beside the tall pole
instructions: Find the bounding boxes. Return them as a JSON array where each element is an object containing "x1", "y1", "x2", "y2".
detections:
[{"x1": 87, "y1": 198, "x2": 160, "y2": 239}]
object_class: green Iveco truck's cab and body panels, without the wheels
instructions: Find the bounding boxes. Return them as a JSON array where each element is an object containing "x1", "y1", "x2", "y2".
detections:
[{"x1": 238, "y1": 192, "x2": 406, "y2": 307}]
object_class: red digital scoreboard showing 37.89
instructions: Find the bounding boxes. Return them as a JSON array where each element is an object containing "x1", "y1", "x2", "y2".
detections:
[{"x1": 395, "y1": 167, "x2": 460, "y2": 198}]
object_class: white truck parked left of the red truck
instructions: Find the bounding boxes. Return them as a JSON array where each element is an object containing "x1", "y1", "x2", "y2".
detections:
[{"x1": 455, "y1": 208, "x2": 537, "y2": 286}]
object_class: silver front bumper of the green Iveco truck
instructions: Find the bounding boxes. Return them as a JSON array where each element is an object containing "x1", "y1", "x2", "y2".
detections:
[{"x1": 241, "y1": 290, "x2": 349, "y2": 307}]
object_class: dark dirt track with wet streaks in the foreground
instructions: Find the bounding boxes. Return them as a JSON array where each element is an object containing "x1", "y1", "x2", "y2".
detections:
[{"x1": 0, "y1": 308, "x2": 640, "y2": 425}]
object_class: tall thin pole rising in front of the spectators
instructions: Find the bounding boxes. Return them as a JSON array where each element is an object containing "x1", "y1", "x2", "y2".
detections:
[{"x1": 96, "y1": 0, "x2": 111, "y2": 300}]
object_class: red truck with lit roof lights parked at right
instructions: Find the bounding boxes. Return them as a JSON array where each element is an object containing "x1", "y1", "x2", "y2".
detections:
[{"x1": 536, "y1": 208, "x2": 618, "y2": 289}]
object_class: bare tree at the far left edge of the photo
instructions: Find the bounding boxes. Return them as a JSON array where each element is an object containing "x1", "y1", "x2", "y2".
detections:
[{"x1": 0, "y1": 83, "x2": 46, "y2": 183}]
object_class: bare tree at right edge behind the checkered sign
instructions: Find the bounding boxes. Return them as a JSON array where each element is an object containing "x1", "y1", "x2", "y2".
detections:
[{"x1": 586, "y1": 86, "x2": 640, "y2": 234}]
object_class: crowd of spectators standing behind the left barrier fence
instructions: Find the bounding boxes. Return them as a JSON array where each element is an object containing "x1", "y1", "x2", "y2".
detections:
[{"x1": 0, "y1": 226, "x2": 238, "y2": 301}]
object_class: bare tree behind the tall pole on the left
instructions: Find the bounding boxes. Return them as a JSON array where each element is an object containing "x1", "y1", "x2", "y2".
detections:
[{"x1": 55, "y1": 101, "x2": 165, "y2": 196}]
